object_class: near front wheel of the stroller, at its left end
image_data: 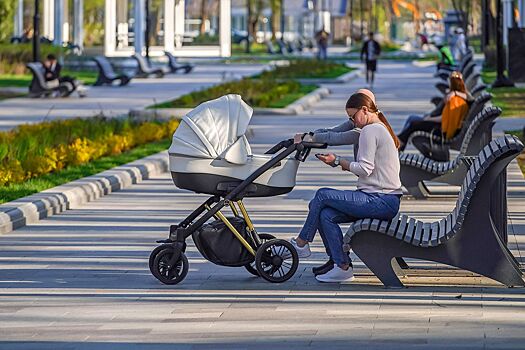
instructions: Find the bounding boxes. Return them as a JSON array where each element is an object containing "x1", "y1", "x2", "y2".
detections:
[{"x1": 153, "y1": 247, "x2": 189, "y2": 284}]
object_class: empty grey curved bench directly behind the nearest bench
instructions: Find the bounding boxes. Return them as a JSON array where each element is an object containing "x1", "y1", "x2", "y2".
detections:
[{"x1": 399, "y1": 106, "x2": 501, "y2": 198}]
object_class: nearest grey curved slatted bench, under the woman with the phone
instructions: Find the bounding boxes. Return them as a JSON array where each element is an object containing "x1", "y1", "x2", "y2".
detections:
[{"x1": 343, "y1": 135, "x2": 525, "y2": 287}]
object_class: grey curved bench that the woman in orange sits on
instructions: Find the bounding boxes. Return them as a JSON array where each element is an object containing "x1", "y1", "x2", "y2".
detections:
[{"x1": 408, "y1": 92, "x2": 492, "y2": 153}]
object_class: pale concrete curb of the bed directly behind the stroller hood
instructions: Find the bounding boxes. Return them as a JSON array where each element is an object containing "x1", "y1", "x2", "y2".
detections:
[{"x1": 129, "y1": 85, "x2": 330, "y2": 119}]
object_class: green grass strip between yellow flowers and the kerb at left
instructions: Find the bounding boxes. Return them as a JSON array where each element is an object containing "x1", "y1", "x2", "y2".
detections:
[{"x1": 0, "y1": 139, "x2": 171, "y2": 203}]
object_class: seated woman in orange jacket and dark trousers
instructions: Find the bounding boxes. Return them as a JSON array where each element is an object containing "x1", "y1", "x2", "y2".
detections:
[{"x1": 397, "y1": 71, "x2": 472, "y2": 151}]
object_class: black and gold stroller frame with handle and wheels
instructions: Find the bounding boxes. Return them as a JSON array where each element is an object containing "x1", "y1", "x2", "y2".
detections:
[{"x1": 149, "y1": 139, "x2": 327, "y2": 284}]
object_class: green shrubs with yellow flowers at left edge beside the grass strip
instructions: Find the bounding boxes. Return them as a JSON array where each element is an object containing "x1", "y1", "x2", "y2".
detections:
[{"x1": 0, "y1": 117, "x2": 179, "y2": 186}]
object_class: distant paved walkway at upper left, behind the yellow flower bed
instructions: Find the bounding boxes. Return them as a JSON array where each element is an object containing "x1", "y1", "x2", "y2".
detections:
[{"x1": 0, "y1": 64, "x2": 265, "y2": 130}]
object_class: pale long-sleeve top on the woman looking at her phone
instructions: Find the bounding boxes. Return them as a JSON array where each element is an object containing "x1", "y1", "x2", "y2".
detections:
[{"x1": 350, "y1": 123, "x2": 403, "y2": 194}]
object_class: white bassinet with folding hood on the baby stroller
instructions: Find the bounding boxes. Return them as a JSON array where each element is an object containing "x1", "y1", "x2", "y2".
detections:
[{"x1": 169, "y1": 95, "x2": 299, "y2": 197}]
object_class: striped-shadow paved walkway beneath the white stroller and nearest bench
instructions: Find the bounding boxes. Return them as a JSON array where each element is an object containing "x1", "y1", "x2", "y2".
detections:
[{"x1": 0, "y1": 63, "x2": 525, "y2": 350}]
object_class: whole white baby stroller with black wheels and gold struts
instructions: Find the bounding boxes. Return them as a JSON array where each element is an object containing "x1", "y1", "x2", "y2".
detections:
[{"x1": 149, "y1": 95, "x2": 326, "y2": 284}]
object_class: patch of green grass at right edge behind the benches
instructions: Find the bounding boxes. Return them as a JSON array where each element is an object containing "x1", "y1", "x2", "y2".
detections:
[{"x1": 481, "y1": 67, "x2": 525, "y2": 117}]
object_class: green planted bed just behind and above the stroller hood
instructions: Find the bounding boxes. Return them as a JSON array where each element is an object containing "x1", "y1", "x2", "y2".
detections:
[{"x1": 153, "y1": 78, "x2": 316, "y2": 108}]
